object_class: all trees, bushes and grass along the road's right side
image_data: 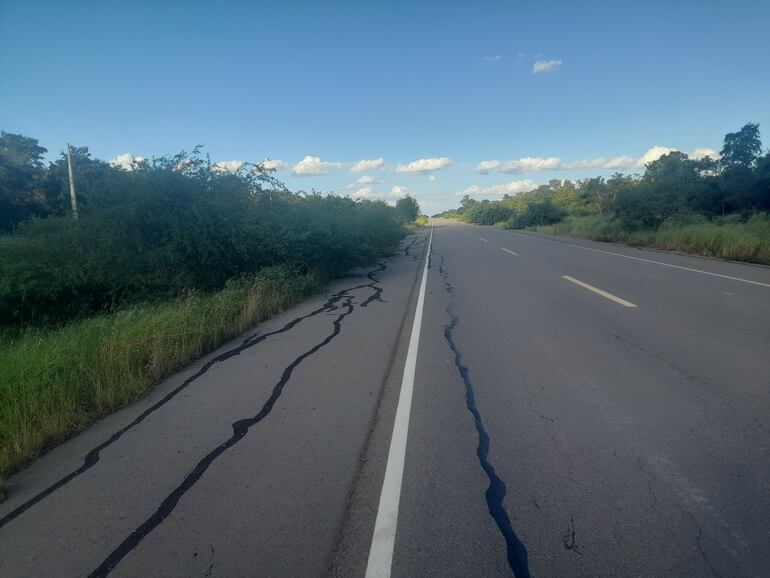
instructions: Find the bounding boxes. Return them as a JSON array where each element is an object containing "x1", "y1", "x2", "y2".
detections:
[{"x1": 440, "y1": 124, "x2": 770, "y2": 264}]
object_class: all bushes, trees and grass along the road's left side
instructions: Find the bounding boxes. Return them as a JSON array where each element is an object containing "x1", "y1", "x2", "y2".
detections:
[{"x1": 0, "y1": 133, "x2": 419, "y2": 482}]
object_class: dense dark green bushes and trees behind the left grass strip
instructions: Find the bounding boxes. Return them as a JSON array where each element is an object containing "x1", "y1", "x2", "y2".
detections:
[{"x1": 0, "y1": 132, "x2": 412, "y2": 327}]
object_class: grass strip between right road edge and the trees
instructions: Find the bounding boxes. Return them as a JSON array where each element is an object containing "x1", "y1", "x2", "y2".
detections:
[{"x1": 532, "y1": 213, "x2": 770, "y2": 265}]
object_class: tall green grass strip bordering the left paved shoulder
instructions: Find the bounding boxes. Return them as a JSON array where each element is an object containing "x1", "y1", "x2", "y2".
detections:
[{"x1": 0, "y1": 269, "x2": 324, "y2": 480}]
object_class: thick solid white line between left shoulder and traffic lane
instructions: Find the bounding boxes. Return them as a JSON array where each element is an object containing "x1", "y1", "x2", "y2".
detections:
[{"x1": 366, "y1": 228, "x2": 433, "y2": 578}]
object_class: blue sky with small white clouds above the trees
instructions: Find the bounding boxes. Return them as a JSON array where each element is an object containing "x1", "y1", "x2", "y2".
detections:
[{"x1": 0, "y1": 0, "x2": 770, "y2": 214}]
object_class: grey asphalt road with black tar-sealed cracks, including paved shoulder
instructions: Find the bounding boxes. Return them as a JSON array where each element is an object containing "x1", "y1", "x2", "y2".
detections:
[{"x1": 0, "y1": 221, "x2": 770, "y2": 578}]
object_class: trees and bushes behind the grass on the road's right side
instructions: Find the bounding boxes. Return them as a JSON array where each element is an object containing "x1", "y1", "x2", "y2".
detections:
[{"x1": 441, "y1": 123, "x2": 770, "y2": 232}]
